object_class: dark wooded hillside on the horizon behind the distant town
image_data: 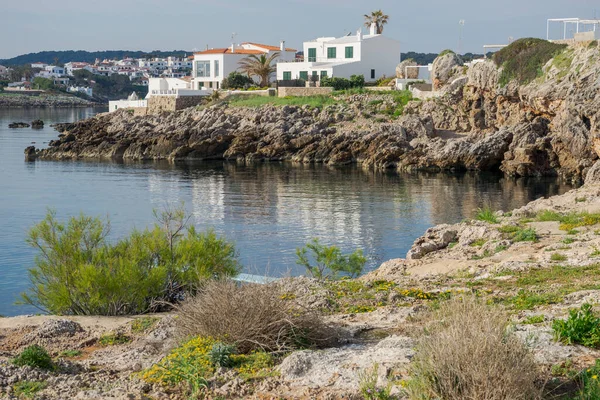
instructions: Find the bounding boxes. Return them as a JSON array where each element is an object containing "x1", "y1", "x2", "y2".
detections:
[{"x1": 0, "y1": 50, "x2": 193, "y2": 66}]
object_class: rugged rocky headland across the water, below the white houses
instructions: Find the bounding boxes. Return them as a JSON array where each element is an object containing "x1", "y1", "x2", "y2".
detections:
[{"x1": 26, "y1": 42, "x2": 600, "y2": 181}]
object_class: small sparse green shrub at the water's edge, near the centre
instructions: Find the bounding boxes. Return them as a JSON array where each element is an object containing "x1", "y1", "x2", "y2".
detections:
[{"x1": 296, "y1": 238, "x2": 367, "y2": 279}]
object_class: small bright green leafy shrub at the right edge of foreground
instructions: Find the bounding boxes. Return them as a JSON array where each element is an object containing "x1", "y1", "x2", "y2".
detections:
[{"x1": 552, "y1": 304, "x2": 600, "y2": 348}]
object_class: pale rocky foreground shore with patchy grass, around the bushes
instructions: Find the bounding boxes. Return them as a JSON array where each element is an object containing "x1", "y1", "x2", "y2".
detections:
[{"x1": 0, "y1": 163, "x2": 600, "y2": 399}]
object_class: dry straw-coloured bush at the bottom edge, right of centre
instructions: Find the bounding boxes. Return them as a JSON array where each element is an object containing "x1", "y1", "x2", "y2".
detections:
[{"x1": 408, "y1": 298, "x2": 542, "y2": 400}]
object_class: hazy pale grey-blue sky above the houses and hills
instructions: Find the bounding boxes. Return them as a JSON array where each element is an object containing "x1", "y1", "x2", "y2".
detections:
[{"x1": 0, "y1": 0, "x2": 600, "y2": 58}]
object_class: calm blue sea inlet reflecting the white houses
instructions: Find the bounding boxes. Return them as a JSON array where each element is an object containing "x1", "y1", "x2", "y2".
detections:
[{"x1": 0, "y1": 109, "x2": 570, "y2": 315}]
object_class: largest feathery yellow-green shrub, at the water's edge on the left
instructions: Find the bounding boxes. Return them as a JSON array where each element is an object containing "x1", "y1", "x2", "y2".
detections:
[{"x1": 22, "y1": 209, "x2": 239, "y2": 315}]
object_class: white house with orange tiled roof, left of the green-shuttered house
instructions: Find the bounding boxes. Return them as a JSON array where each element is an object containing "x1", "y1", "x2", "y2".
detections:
[{"x1": 192, "y1": 41, "x2": 296, "y2": 89}]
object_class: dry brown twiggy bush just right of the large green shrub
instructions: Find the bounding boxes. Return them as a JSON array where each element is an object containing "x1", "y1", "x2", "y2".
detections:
[{"x1": 177, "y1": 281, "x2": 336, "y2": 352}]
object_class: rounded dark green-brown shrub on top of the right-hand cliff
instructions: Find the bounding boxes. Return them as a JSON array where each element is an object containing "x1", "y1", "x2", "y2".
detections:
[{"x1": 493, "y1": 38, "x2": 567, "y2": 86}]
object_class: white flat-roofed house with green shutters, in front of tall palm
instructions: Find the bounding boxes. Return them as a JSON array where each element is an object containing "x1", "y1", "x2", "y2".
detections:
[{"x1": 277, "y1": 24, "x2": 400, "y2": 81}]
